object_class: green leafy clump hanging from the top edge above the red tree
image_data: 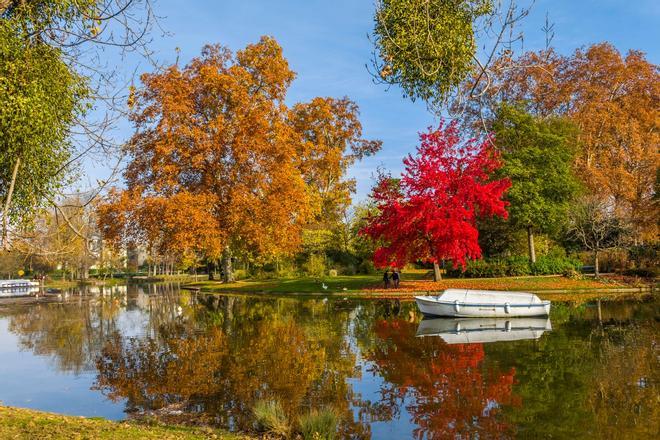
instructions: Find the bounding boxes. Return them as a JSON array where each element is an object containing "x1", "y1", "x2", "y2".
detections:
[{"x1": 374, "y1": 0, "x2": 492, "y2": 104}]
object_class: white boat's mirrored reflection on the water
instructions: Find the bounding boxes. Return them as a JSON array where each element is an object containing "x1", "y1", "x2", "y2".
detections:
[{"x1": 417, "y1": 317, "x2": 552, "y2": 344}]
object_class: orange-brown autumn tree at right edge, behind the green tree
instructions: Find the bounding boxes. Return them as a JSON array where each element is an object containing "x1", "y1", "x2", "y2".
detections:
[{"x1": 458, "y1": 43, "x2": 660, "y2": 241}]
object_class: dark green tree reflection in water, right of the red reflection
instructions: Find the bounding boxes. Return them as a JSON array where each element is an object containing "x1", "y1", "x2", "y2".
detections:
[{"x1": 496, "y1": 303, "x2": 660, "y2": 438}]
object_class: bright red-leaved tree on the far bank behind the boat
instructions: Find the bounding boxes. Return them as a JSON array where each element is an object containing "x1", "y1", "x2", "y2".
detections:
[{"x1": 362, "y1": 122, "x2": 511, "y2": 281}]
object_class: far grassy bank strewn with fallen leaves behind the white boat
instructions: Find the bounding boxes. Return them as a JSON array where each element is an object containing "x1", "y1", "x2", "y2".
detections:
[{"x1": 189, "y1": 271, "x2": 652, "y2": 297}]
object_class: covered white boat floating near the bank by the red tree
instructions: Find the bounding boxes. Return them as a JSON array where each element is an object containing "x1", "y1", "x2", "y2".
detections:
[{"x1": 415, "y1": 289, "x2": 550, "y2": 318}]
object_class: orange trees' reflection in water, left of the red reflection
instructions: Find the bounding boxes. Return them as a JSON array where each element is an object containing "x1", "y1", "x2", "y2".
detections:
[{"x1": 97, "y1": 297, "x2": 362, "y2": 434}]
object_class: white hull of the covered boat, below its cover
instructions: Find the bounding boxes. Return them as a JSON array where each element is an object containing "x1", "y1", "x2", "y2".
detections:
[{"x1": 415, "y1": 296, "x2": 550, "y2": 318}]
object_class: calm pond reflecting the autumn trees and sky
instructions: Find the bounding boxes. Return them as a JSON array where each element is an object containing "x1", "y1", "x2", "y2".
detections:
[{"x1": 0, "y1": 284, "x2": 660, "y2": 439}]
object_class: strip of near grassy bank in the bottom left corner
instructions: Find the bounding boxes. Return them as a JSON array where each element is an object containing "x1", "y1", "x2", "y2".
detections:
[{"x1": 0, "y1": 406, "x2": 249, "y2": 440}]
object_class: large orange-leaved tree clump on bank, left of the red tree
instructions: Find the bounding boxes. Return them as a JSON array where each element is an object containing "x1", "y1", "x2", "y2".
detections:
[{"x1": 100, "y1": 37, "x2": 380, "y2": 281}]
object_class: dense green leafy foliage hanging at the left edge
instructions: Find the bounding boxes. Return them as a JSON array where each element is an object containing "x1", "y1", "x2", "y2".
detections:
[{"x1": 0, "y1": 18, "x2": 87, "y2": 247}]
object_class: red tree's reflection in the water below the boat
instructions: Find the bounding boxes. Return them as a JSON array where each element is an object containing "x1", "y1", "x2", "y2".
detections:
[{"x1": 368, "y1": 320, "x2": 520, "y2": 438}]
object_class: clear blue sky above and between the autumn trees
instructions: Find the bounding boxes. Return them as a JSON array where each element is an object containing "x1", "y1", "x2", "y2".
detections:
[{"x1": 86, "y1": 0, "x2": 660, "y2": 200}]
